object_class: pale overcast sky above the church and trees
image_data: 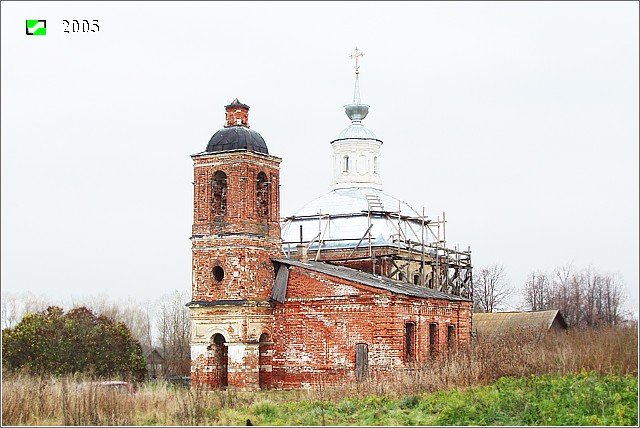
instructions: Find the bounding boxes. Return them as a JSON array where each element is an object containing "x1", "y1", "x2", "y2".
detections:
[{"x1": 1, "y1": 2, "x2": 639, "y2": 316}]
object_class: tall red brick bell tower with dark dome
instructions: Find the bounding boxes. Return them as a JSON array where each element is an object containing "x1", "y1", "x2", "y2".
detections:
[{"x1": 189, "y1": 99, "x2": 281, "y2": 390}]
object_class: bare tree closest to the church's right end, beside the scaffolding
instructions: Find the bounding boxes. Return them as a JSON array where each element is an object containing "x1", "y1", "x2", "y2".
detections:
[{"x1": 473, "y1": 264, "x2": 513, "y2": 312}]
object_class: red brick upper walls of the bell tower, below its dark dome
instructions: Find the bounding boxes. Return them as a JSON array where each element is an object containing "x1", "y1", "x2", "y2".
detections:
[{"x1": 191, "y1": 151, "x2": 281, "y2": 301}]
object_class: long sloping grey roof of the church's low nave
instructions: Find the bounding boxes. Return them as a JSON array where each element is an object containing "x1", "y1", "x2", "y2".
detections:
[{"x1": 272, "y1": 259, "x2": 470, "y2": 302}]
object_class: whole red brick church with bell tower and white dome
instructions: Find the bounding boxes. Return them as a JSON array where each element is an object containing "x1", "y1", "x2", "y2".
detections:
[{"x1": 188, "y1": 50, "x2": 472, "y2": 390}]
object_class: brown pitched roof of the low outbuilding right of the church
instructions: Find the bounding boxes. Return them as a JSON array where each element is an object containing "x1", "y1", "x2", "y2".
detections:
[{"x1": 473, "y1": 309, "x2": 567, "y2": 334}]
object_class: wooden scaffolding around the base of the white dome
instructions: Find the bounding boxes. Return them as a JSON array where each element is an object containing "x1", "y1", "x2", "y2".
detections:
[{"x1": 282, "y1": 203, "x2": 473, "y2": 299}]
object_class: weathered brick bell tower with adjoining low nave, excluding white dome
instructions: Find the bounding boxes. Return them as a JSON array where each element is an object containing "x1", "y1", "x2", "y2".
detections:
[{"x1": 189, "y1": 100, "x2": 471, "y2": 390}]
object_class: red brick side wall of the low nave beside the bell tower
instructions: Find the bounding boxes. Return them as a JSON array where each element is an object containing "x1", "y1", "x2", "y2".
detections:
[{"x1": 272, "y1": 268, "x2": 471, "y2": 388}]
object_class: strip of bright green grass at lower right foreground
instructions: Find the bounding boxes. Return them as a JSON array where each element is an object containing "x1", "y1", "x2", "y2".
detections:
[{"x1": 242, "y1": 372, "x2": 638, "y2": 426}]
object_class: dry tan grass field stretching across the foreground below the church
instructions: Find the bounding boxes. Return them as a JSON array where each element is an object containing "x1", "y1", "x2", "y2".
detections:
[{"x1": 2, "y1": 326, "x2": 638, "y2": 425}]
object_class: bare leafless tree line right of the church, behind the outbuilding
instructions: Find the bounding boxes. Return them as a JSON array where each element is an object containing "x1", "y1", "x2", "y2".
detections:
[{"x1": 473, "y1": 264, "x2": 629, "y2": 327}]
